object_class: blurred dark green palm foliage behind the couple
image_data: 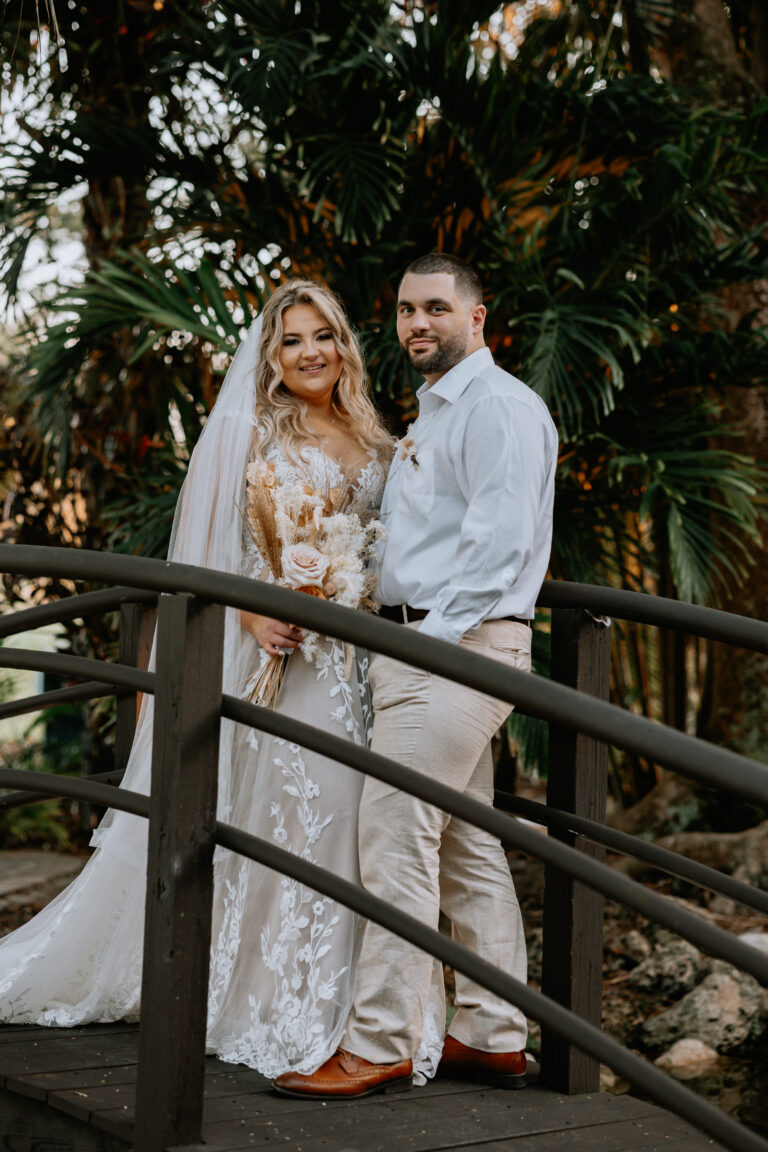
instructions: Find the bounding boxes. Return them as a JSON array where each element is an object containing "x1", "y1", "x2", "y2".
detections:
[{"x1": 0, "y1": 0, "x2": 768, "y2": 803}]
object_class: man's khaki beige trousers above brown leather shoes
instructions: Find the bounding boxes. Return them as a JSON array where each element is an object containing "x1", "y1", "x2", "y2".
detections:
[{"x1": 343, "y1": 620, "x2": 531, "y2": 1063}]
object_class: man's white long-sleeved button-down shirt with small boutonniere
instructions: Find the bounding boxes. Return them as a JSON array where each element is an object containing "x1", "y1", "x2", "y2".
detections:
[{"x1": 379, "y1": 348, "x2": 557, "y2": 643}]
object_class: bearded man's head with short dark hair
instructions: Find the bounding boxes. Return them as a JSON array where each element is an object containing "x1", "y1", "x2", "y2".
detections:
[{"x1": 397, "y1": 272, "x2": 485, "y2": 384}]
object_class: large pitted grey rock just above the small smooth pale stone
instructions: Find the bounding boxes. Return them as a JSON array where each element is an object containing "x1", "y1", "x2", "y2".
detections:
[{"x1": 642, "y1": 961, "x2": 768, "y2": 1052}]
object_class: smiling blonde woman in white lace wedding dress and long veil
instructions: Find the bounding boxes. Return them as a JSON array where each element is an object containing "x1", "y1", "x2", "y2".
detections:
[{"x1": 0, "y1": 280, "x2": 442, "y2": 1078}]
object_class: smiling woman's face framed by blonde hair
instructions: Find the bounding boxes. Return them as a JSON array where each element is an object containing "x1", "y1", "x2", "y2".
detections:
[{"x1": 279, "y1": 304, "x2": 342, "y2": 408}]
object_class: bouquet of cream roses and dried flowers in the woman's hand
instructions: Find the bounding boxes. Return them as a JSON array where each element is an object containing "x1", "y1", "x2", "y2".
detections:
[{"x1": 245, "y1": 462, "x2": 383, "y2": 707}]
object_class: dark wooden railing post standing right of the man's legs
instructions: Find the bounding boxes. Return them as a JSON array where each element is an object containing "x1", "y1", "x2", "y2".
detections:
[{"x1": 541, "y1": 608, "x2": 610, "y2": 1096}]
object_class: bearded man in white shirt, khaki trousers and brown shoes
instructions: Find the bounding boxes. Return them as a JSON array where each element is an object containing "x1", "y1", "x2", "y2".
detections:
[{"x1": 275, "y1": 253, "x2": 557, "y2": 1099}]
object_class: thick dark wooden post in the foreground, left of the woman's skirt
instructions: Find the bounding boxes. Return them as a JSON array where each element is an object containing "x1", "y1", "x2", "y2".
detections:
[{"x1": 134, "y1": 596, "x2": 223, "y2": 1152}]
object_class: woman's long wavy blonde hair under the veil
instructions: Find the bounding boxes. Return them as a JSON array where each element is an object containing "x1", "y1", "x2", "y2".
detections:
[{"x1": 254, "y1": 280, "x2": 394, "y2": 461}]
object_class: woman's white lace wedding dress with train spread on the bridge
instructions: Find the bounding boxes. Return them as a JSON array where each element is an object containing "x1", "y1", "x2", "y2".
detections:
[{"x1": 0, "y1": 448, "x2": 444, "y2": 1078}]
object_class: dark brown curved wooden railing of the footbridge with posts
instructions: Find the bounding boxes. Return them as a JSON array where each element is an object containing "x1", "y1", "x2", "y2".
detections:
[{"x1": 0, "y1": 546, "x2": 768, "y2": 1152}]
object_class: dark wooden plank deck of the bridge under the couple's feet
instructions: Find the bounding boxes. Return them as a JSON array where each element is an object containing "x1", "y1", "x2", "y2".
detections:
[{"x1": 0, "y1": 1024, "x2": 721, "y2": 1152}]
